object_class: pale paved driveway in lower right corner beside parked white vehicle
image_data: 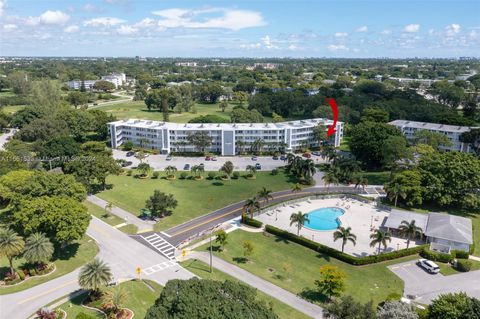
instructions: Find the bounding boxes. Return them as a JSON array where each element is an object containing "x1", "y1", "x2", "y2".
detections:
[{"x1": 388, "y1": 260, "x2": 480, "y2": 304}]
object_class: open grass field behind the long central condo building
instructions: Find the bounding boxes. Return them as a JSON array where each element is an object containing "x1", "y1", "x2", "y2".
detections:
[{"x1": 96, "y1": 101, "x2": 233, "y2": 123}]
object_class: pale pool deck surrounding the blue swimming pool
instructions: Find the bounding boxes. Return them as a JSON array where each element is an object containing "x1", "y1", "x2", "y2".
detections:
[{"x1": 256, "y1": 198, "x2": 421, "y2": 257}]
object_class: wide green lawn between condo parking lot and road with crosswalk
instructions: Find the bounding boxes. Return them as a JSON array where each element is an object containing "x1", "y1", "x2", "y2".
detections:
[{"x1": 98, "y1": 172, "x2": 293, "y2": 230}]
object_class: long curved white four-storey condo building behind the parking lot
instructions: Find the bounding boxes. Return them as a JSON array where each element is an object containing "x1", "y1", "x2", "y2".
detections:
[{"x1": 108, "y1": 118, "x2": 343, "y2": 156}]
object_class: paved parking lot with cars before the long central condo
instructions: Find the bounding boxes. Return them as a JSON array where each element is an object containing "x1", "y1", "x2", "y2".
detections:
[{"x1": 113, "y1": 150, "x2": 325, "y2": 171}]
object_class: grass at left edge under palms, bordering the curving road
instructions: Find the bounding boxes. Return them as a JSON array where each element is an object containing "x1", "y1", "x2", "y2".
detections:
[{"x1": 0, "y1": 236, "x2": 98, "y2": 295}]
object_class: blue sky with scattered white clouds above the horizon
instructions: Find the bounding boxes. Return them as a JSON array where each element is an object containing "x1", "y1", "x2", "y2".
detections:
[{"x1": 0, "y1": 0, "x2": 480, "y2": 58}]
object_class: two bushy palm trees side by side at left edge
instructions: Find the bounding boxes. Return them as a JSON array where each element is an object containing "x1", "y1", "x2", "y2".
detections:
[{"x1": 0, "y1": 228, "x2": 54, "y2": 277}]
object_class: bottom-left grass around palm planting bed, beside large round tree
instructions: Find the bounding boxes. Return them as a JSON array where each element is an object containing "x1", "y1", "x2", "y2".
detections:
[{"x1": 58, "y1": 280, "x2": 162, "y2": 319}]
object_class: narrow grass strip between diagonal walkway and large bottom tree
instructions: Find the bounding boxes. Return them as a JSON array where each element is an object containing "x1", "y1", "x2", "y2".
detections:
[{"x1": 180, "y1": 259, "x2": 310, "y2": 319}]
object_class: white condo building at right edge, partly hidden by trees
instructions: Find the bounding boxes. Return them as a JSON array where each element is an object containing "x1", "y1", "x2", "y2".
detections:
[{"x1": 389, "y1": 120, "x2": 473, "y2": 153}]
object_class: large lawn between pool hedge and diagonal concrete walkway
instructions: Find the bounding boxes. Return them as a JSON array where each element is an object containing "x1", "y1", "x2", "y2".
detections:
[{"x1": 198, "y1": 230, "x2": 418, "y2": 304}]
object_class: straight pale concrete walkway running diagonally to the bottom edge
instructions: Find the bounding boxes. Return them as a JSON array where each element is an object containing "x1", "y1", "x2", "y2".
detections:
[{"x1": 188, "y1": 252, "x2": 323, "y2": 318}]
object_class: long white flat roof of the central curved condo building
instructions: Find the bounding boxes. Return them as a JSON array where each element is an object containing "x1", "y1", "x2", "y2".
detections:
[{"x1": 108, "y1": 118, "x2": 342, "y2": 130}]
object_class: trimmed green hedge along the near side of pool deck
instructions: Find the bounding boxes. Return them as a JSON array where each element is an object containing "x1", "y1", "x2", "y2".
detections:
[{"x1": 265, "y1": 225, "x2": 428, "y2": 266}]
